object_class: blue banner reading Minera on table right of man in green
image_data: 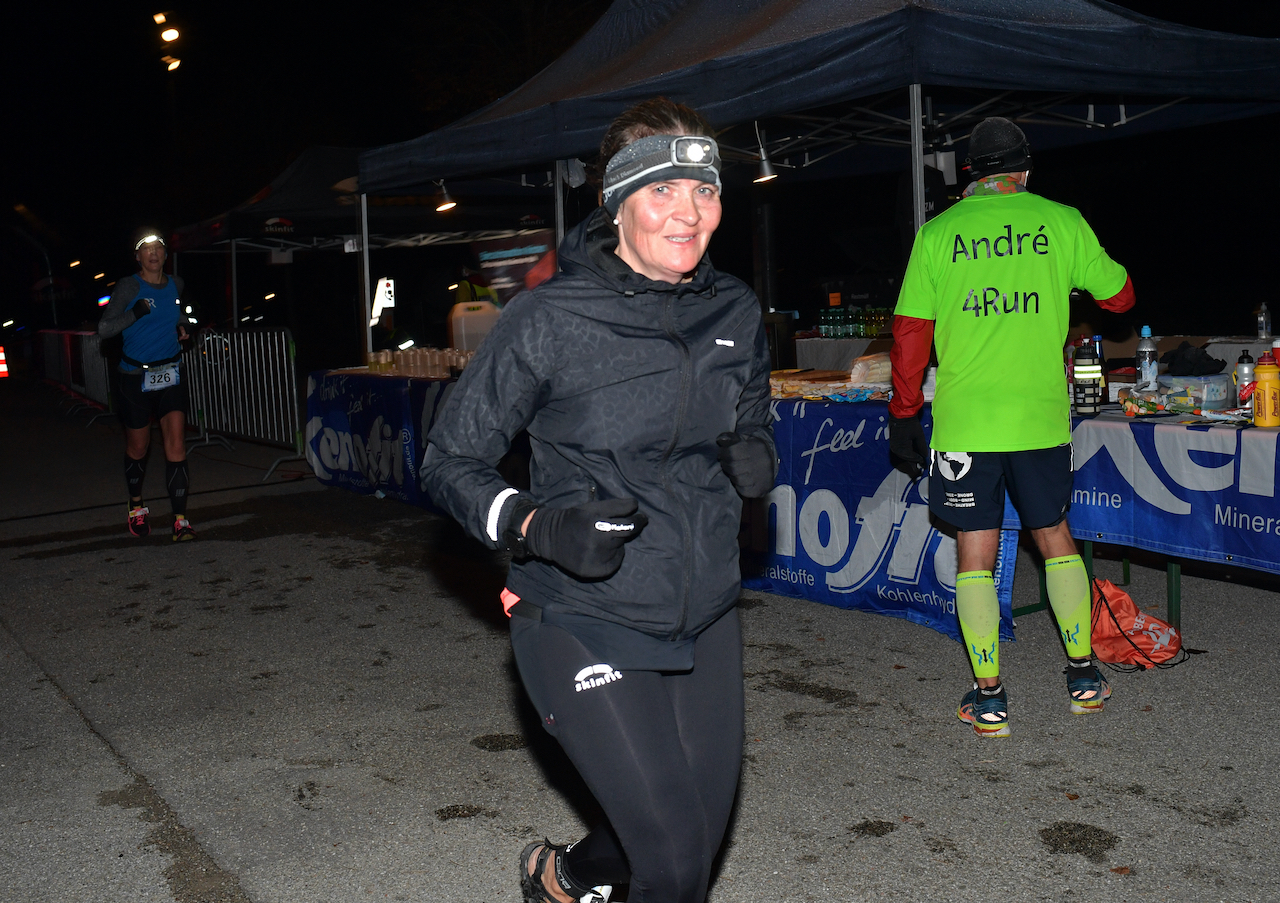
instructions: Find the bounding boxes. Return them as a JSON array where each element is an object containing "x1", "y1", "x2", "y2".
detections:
[{"x1": 1070, "y1": 414, "x2": 1280, "y2": 574}]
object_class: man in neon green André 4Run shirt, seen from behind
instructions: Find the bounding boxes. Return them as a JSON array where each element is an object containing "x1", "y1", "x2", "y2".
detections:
[{"x1": 890, "y1": 117, "x2": 1134, "y2": 736}]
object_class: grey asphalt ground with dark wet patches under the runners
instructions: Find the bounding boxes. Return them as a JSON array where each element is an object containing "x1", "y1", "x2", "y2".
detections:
[{"x1": 0, "y1": 368, "x2": 1280, "y2": 903}]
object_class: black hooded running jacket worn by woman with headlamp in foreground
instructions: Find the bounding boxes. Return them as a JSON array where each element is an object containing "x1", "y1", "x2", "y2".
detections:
[{"x1": 420, "y1": 207, "x2": 776, "y2": 640}]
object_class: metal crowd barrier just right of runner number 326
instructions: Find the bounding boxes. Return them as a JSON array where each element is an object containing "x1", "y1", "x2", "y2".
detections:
[{"x1": 182, "y1": 329, "x2": 305, "y2": 483}]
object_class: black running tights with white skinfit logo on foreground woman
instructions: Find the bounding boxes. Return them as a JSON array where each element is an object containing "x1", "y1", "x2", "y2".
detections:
[{"x1": 511, "y1": 610, "x2": 742, "y2": 903}]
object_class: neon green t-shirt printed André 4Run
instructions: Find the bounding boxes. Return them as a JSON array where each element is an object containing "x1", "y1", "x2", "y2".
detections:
[{"x1": 895, "y1": 186, "x2": 1126, "y2": 452}]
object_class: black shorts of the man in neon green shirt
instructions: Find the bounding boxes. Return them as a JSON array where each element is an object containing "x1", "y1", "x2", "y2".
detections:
[{"x1": 929, "y1": 443, "x2": 1073, "y2": 532}]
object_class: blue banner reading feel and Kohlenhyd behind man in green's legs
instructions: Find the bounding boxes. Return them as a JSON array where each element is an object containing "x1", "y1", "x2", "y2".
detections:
[{"x1": 744, "y1": 401, "x2": 1013, "y2": 642}]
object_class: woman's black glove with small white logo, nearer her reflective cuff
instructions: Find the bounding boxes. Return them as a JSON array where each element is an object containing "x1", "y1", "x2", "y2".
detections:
[{"x1": 511, "y1": 498, "x2": 649, "y2": 580}]
